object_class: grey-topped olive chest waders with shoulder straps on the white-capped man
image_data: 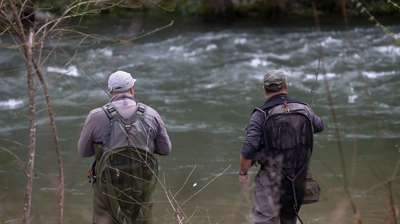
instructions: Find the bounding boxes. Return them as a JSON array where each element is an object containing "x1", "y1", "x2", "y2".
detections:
[{"x1": 94, "y1": 103, "x2": 158, "y2": 224}]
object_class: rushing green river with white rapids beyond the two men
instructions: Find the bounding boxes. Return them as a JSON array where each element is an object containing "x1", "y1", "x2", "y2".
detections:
[{"x1": 0, "y1": 16, "x2": 400, "y2": 224}]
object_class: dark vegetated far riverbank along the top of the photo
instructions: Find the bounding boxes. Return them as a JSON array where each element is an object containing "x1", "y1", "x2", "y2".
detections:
[{"x1": 37, "y1": 0, "x2": 399, "y2": 22}]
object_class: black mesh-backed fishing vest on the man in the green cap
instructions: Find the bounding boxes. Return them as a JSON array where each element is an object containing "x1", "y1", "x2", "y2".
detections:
[{"x1": 253, "y1": 95, "x2": 314, "y2": 169}]
